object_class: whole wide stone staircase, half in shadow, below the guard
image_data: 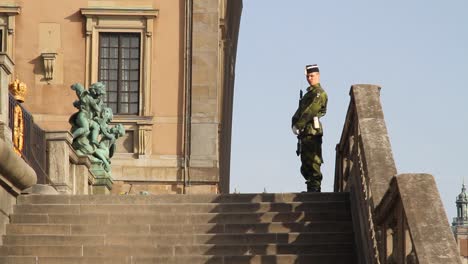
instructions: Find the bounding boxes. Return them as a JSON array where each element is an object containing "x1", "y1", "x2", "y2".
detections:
[{"x1": 0, "y1": 193, "x2": 357, "y2": 264}]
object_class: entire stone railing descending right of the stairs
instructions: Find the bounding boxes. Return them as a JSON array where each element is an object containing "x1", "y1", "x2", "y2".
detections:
[{"x1": 335, "y1": 85, "x2": 461, "y2": 264}]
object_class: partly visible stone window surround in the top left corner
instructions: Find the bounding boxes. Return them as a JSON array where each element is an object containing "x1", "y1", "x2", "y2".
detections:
[{"x1": 0, "y1": 6, "x2": 21, "y2": 59}]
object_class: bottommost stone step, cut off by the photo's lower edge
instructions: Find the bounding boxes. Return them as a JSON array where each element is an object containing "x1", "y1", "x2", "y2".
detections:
[{"x1": 0, "y1": 254, "x2": 355, "y2": 264}]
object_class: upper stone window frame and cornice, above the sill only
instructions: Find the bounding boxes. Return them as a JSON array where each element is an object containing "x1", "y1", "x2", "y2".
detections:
[{"x1": 81, "y1": 8, "x2": 159, "y2": 116}]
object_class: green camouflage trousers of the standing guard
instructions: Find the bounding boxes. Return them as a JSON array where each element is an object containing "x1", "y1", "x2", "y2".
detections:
[{"x1": 301, "y1": 136, "x2": 323, "y2": 191}]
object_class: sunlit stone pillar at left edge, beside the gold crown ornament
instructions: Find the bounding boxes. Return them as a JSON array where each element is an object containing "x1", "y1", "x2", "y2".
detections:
[{"x1": 0, "y1": 53, "x2": 14, "y2": 144}]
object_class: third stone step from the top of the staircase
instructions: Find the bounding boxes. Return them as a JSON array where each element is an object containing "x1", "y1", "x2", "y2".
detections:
[{"x1": 10, "y1": 211, "x2": 350, "y2": 224}]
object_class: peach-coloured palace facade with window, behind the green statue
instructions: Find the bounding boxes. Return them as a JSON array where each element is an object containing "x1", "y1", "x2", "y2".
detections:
[{"x1": 0, "y1": 0, "x2": 242, "y2": 193}]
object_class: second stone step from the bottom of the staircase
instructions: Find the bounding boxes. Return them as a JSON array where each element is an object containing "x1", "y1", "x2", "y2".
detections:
[{"x1": 0, "y1": 242, "x2": 353, "y2": 257}]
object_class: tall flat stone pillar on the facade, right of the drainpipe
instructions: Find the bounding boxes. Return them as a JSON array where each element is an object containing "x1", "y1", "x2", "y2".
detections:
[{"x1": 186, "y1": 0, "x2": 220, "y2": 193}]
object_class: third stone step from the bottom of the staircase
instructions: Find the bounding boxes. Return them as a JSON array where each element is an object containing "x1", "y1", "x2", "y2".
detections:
[{"x1": 3, "y1": 232, "x2": 353, "y2": 246}]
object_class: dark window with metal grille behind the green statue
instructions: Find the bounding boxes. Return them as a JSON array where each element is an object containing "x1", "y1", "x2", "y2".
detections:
[{"x1": 98, "y1": 33, "x2": 140, "y2": 115}]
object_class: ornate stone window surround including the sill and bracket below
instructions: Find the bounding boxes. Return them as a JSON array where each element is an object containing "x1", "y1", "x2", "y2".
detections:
[{"x1": 81, "y1": 8, "x2": 159, "y2": 159}]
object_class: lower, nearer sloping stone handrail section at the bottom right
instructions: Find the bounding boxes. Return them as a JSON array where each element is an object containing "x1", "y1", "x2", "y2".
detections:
[{"x1": 374, "y1": 174, "x2": 461, "y2": 263}]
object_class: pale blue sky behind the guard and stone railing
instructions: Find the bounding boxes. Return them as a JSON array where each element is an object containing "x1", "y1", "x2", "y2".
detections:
[{"x1": 231, "y1": 0, "x2": 468, "y2": 222}]
